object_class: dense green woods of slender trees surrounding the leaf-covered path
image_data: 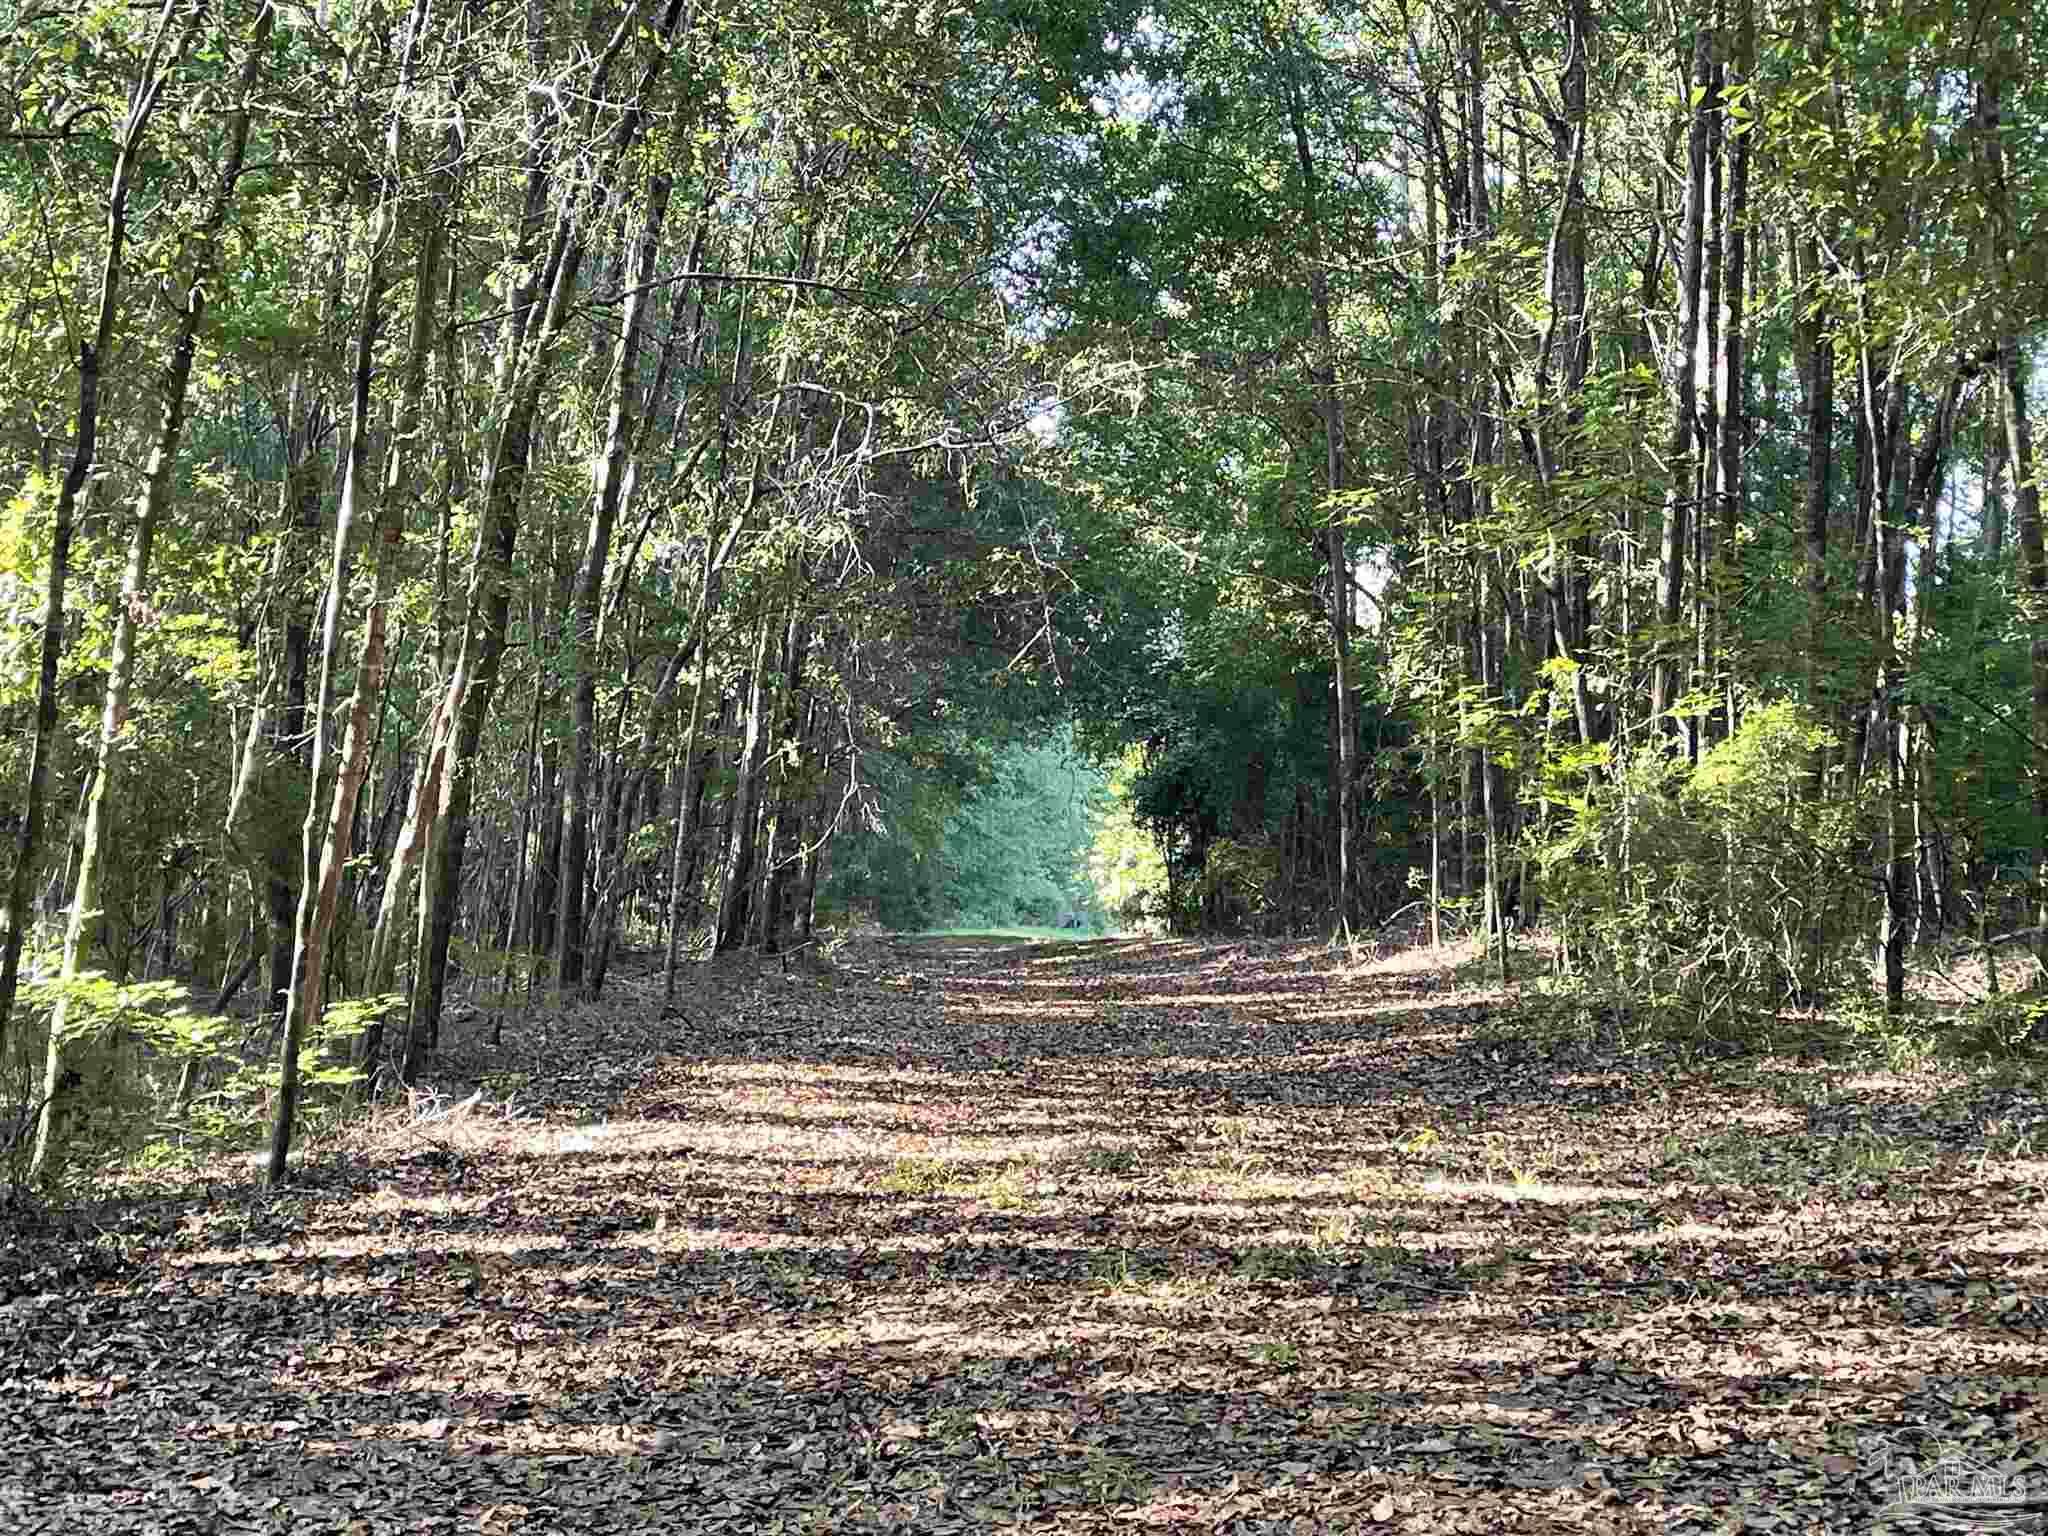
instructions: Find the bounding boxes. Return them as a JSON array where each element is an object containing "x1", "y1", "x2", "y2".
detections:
[{"x1": 0, "y1": 0, "x2": 2048, "y2": 1180}]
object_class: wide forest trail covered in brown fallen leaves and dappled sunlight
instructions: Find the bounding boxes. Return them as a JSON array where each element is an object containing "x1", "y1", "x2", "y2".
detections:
[{"x1": 0, "y1": 938, "x2": 2048, "y2": 1534}]
